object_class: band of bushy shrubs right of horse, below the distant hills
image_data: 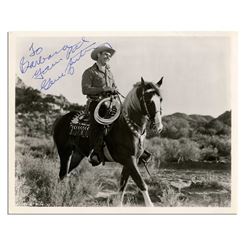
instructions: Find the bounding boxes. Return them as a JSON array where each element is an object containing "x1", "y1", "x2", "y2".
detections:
[{"x1": 146, "y1": 134, "x2": 231, "y2": 162}]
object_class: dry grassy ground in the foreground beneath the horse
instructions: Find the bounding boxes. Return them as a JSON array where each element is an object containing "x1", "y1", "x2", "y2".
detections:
[{"x1": 16, "y1": 136, "x2": 231, "y2": 207}]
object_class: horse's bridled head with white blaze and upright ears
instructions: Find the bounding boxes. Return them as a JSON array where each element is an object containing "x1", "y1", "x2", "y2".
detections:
[{"x1": 139, "y1": 77, "x2": 163, "y2": 133}]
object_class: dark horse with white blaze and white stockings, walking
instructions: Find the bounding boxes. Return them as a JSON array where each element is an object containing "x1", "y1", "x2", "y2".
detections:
[{"x1": 53, "y1": 77, "x2": 163, "y2": 207}]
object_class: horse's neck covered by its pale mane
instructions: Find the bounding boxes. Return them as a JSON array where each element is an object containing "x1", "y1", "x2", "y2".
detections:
[{"x1": 123, "y1": 89, "x2": 147, "y2": 131}]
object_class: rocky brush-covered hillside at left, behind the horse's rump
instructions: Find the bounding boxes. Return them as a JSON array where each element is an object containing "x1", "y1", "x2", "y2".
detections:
[{"x1": 15, "y1": 77, "x2": 83, "y2": 136}]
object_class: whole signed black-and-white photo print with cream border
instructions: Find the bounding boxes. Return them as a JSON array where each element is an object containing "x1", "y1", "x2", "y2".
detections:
[{"x1": 9, "y1": 32, "x2": 237, "y2": 213}]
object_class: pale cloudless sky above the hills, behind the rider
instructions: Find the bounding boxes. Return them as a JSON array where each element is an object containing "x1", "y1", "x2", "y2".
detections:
[{"x1": 15, "y1": 33, "x2": 234, "y2": 117}]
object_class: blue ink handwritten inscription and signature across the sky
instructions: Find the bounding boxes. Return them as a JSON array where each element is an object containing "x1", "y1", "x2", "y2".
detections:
[{"x1": 19, "y1": 38, "x2": 111, "y2": 90}]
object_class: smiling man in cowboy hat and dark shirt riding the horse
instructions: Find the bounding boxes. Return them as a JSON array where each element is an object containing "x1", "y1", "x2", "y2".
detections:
[{"x1": 82, "y1": 45, "x2": 116, "y2": 165}]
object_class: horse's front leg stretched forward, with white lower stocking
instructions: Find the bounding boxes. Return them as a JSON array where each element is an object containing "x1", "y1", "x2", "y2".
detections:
[{"x1": 126, "y1": 156, "x2": 154, "y2": 207}]
